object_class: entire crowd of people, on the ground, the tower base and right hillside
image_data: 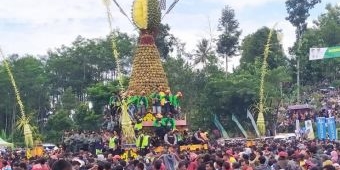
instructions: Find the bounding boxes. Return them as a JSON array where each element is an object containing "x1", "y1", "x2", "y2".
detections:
[{"x1": 0, "y1": 87, "x2": 340, "y2": 170}]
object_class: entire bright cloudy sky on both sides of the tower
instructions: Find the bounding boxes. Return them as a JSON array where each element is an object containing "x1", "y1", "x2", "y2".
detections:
[{"x1": 0, "y1": 0, "x2": 338, "y2": 70}]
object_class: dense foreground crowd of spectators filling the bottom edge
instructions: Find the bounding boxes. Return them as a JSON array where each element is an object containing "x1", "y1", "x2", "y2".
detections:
[{"x1": 0, "y1": 139, "x2": 340, "y2": 170}]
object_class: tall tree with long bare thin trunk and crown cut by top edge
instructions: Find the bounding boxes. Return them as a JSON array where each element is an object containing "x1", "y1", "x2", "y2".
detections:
[{"x1": 286, "y1": 0, "x2": 321, "y2": 102}]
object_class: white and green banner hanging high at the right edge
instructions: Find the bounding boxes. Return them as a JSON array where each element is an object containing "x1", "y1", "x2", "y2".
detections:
[{"x1": 309, "y1": 46, "x2": 340, "y2": 60}]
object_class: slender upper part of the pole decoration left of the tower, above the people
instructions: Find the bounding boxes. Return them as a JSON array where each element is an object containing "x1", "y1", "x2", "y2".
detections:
[{"x1": 103, "y1": 0, "x2": 123, "y2": 88}]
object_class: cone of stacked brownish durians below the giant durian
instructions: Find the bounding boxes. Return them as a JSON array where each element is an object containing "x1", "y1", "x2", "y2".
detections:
[{"x1": 129, "y1": 34, "x2": 168, "y2": 94}]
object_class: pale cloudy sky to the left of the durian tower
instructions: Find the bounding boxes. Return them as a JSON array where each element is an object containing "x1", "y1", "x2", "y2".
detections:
[{"x1": 0, "y1": 0, "x2": 137, "y2": 54}]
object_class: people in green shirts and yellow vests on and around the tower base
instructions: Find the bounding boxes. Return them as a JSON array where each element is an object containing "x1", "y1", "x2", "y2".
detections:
[{"x1": 62, "y1": 87, "x2": 209, "y2": 159}]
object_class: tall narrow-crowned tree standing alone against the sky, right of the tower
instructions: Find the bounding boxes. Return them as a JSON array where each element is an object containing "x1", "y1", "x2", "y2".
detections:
[{"x1": 217, "y1": 6, "x2": 241, "y2": 72}]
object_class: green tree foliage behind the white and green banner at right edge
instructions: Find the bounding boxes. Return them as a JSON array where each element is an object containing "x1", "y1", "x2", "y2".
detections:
[{"x1": 291, "y1": 5, "x2": 340, "y2": 85}]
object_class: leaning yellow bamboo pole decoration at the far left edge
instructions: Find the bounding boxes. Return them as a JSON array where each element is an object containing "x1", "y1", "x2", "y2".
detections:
[{"x1": 0, "y1": 48, "x2": 33, "y2": 148}]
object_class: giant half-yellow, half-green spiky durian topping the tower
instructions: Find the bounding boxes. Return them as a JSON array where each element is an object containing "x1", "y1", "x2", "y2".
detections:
[{"x1": 132, "y1": 0, "x2": 162, "y2": 30}]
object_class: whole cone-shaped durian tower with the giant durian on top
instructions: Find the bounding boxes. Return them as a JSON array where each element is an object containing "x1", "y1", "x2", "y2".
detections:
[{"x1": 129, "y1": 0, "x2": 168, "y2": 94}]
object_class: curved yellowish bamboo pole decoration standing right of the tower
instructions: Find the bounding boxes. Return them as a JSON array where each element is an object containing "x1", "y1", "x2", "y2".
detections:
[{"x1": 256, "y1": 24, "x2": 277, "y2": 135}]
